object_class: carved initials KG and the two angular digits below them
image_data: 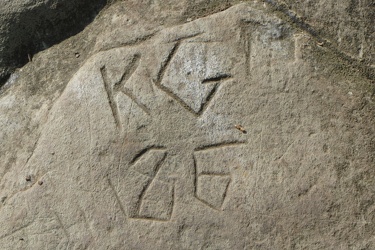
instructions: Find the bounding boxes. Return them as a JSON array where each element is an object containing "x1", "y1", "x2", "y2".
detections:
[{"x1": 100, "y1": 38, "x2": 245, "y2": 221}]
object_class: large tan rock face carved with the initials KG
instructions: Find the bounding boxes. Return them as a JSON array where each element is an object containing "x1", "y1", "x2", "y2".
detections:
[{"x1": 0, "y1": 1, "x2": 375, "y2": 249}]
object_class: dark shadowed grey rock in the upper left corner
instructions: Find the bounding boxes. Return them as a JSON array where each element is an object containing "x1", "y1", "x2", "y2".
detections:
[{"x1": 0, "y1": 0, "x2": 107, "y2": 86}]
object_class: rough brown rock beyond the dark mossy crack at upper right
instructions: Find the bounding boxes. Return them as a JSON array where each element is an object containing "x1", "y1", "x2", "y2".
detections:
[{"x1": 266, "y1": 0, "x2": 375, "y2": 67}]
